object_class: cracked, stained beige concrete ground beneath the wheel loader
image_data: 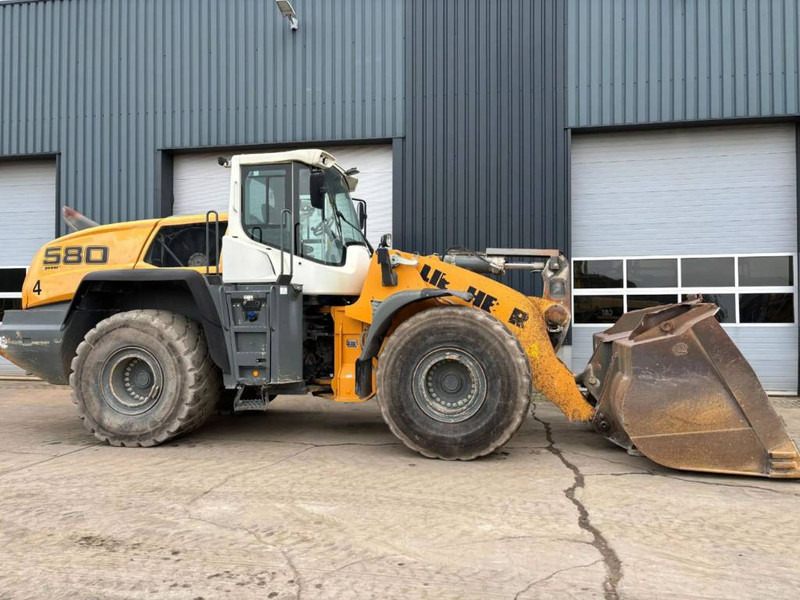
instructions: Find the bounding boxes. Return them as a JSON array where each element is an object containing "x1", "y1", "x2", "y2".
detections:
[{"x1": 0, "y1": 382, "x2": 800, "y2": 600}]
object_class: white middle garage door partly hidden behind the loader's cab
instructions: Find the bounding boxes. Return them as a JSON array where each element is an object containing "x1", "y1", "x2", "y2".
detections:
[{"x1": 172, "y1": 145, "x2": 392, "y2": 245}]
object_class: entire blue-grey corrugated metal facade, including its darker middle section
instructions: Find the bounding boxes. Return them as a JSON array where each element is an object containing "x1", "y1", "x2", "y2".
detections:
[{"x1": 0, "y1": 0, "x2": 800, "y2": 291}]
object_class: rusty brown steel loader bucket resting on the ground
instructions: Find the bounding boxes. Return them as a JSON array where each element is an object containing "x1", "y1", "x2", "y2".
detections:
[{"x1": 582, "y1": 300, "x2": 800, "y2": 477}]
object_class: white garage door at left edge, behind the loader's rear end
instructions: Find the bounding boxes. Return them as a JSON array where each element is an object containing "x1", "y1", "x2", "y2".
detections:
[{"x1": 0, "y1": 160, "x2": 56, "y2": 375}]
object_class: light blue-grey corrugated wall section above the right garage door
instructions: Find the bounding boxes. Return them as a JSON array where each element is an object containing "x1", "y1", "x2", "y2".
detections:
[{"x1": 566, "y1": 0, "x2": 800, "y2": 127}]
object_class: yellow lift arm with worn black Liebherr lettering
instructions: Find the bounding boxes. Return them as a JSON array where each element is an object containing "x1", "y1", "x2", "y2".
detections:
[{"x1": 345, "y1": 250, "x2": 594, "y2": 421}]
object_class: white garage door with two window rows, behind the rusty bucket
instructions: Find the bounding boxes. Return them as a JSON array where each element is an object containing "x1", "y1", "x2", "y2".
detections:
[{"x1": 572, "y1": 125, "x2": 798, "y2": 393}]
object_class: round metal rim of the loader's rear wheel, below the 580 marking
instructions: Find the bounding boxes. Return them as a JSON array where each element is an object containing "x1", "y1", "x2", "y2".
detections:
[{"x1": 100, "y1": 346, "x2": 164, "y2": 416}]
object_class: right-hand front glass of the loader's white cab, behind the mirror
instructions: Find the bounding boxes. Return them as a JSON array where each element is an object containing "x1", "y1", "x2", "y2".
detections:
[{"x1": 299, "y1": 166, "x2": 364, "y2": 264}]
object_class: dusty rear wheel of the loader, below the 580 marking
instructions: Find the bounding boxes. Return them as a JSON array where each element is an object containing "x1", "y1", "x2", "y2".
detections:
[{"x1": 69, "y1": 310, "x2": 220, "y2": 446}]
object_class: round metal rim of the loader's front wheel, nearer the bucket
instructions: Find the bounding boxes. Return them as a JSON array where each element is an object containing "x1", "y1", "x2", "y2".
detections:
[{"x1": 413, "y1": 348, "x2": 487, "y2": 423}]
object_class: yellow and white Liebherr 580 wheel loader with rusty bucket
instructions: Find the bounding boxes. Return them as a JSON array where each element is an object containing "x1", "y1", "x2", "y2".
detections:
[{"x1": 0, "y1": 150, "x2": 800, "y2": 478}]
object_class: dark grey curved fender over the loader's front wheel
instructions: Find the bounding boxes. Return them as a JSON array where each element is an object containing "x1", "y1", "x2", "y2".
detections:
[{"x1": 356, "y1": 288, "x2": 472, "y2": 398}]
